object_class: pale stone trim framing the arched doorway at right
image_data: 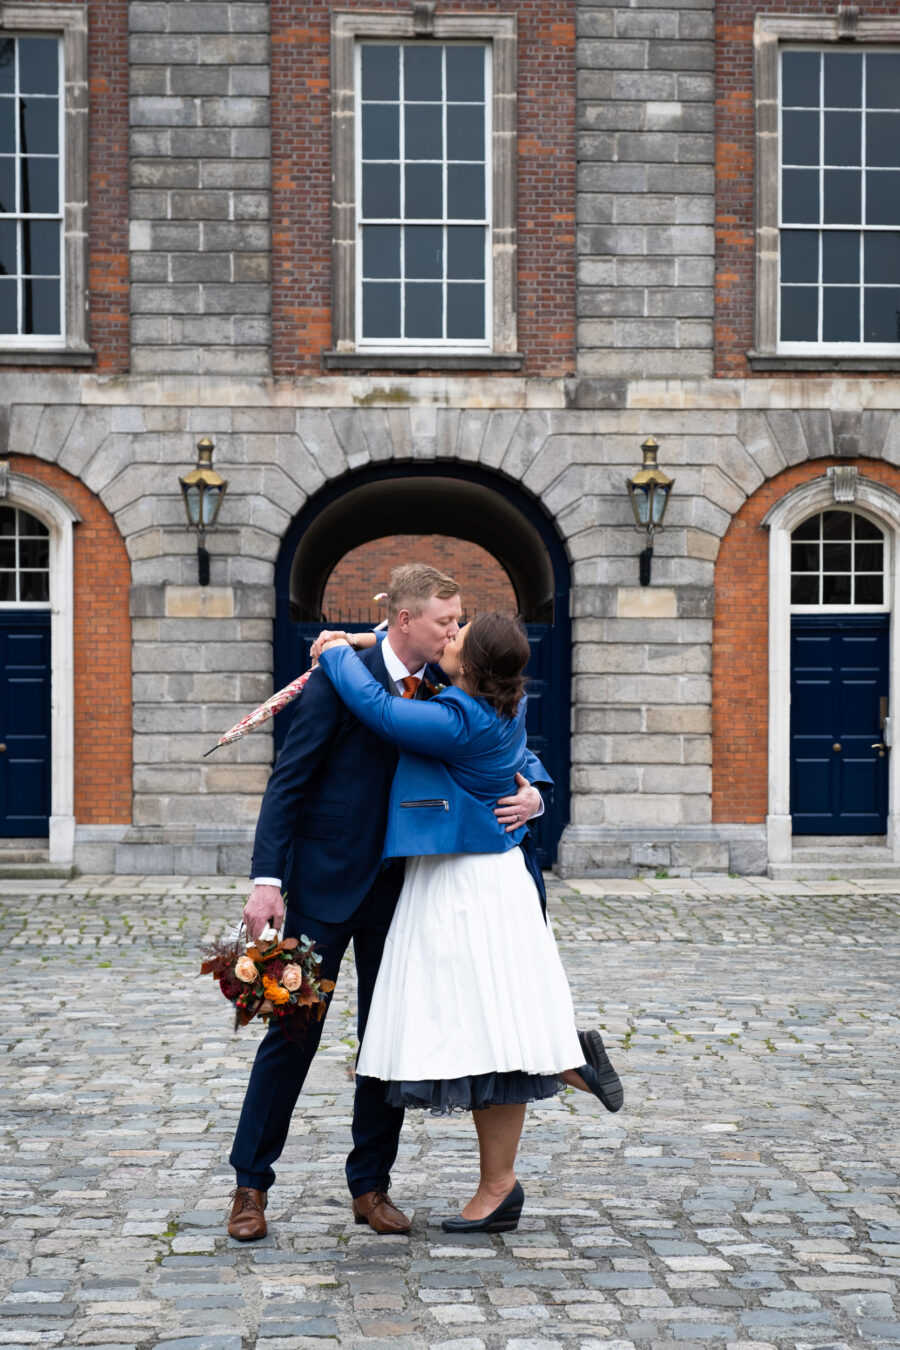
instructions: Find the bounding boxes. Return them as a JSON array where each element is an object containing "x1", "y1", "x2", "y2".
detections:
[{"x1": 761, "y1": 474, "x2": 900, "y2": 863}]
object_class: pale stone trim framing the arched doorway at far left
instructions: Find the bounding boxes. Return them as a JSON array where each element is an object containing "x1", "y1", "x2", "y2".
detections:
[{"x1": 4, "y1": 474, "x2": 81, "y2": 863}]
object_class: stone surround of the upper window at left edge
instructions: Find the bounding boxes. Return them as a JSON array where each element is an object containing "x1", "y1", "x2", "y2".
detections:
[{"x1": 0, "y1": 3, "x2": 93, "y2": 365}]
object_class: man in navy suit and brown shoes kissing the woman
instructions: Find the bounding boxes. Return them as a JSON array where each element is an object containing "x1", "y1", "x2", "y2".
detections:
[{"x1": 228, "y1": 563, "x2": 542, "y2": 1242}]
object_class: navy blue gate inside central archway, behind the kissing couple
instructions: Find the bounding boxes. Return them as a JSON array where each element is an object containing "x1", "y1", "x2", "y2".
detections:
[{"x1": 274, "y1": 624, "x2": 568, "y2": 867}]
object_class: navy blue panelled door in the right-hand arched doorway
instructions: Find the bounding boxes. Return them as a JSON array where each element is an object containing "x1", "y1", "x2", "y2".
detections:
[{"x1": 791, "y1": 614, "x2": 889, "y2": 834}]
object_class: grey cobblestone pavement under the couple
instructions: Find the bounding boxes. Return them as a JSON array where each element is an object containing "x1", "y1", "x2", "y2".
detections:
[{"x1": 0, "y1": 878, "x2": 900, "y2": 1350}]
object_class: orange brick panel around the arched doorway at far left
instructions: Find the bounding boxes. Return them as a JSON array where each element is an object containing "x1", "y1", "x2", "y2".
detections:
[{"x1": 9, "y1": 455, "x2": 132, "y2": 825}]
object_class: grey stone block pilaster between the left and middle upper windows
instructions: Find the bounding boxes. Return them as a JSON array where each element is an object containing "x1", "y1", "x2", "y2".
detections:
[{"x1": 128, "y1": 0, "x2": 271, "y2": 374}]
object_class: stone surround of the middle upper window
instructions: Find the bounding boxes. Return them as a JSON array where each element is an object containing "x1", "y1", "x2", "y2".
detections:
[{"x1": 324, "y1": 4, "x2": 524, "y2": 369}]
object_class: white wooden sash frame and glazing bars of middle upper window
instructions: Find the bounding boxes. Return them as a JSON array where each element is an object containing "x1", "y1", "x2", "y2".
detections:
[{"x1": 354, "y1": 39, "x2": 494, "y2": 352}]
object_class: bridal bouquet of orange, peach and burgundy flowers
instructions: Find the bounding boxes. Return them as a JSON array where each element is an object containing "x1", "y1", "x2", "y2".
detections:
[{"x1": 200, "y1": 929, "x2": 335, "y2": 1041}]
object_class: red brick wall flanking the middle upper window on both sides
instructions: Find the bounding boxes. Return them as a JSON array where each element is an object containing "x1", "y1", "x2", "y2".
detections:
[{"x1": 271, "y1": 0, "x2": 575, "y2": 375}]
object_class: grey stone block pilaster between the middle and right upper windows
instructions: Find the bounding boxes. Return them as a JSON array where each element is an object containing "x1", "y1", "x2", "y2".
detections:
[{"x1": 576, "y1": 0, "x2": 715, "y2": 386}]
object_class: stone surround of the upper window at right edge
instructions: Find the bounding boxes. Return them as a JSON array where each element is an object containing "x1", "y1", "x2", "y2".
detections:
[{"x1": 748, "y1": 8, "x2": 900, "y2": 370}]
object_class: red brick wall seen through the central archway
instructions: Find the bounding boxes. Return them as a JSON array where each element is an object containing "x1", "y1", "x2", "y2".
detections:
[{"x1": 322, "y1": 535, "x2": 517, "y2": 622}]
